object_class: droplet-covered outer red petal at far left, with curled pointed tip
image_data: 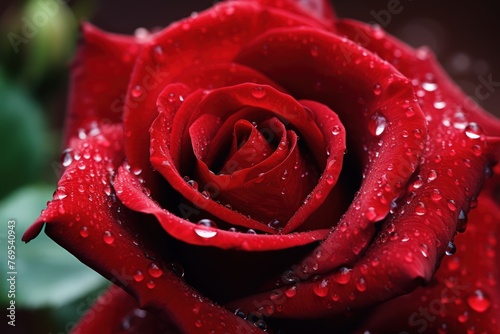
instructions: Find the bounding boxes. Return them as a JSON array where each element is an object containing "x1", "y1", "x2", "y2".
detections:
[{"x1": 23, "y1": 126, "x2": 257, "y2": 333}]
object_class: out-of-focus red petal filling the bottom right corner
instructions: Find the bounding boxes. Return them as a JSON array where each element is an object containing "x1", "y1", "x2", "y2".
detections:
[{"x1": 359, "y1": 190, "x2": 500, "y2": 333}]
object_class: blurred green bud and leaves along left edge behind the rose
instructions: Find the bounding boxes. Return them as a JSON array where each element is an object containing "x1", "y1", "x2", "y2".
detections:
[{"x1": 0, "y1": 0, "x2": 108, "y2": 333}]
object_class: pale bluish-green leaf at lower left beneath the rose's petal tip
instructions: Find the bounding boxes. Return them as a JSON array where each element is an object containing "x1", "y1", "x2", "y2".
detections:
[{"x1": 0, "y1": 185, "x2": 107, "y2": 308}]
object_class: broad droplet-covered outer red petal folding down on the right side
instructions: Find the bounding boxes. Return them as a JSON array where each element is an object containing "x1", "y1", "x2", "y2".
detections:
[{"x1": 226, "y1": 20, "x2": 498, "y2": 318}]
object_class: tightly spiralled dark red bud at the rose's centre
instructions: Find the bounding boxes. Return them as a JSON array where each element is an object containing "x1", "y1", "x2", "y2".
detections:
[{"x1": 192, "y1": 108, "x2": 319, "y2": 230}]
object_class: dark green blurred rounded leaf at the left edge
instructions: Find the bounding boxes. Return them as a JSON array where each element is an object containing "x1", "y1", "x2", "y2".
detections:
[{"x1": 0, "y1": 69, "x2": 50, "y2": 198}]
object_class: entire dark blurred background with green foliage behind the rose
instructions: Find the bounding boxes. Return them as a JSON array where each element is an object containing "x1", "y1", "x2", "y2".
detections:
[{"x1": 0, "y1": 0, "x2": 500, "y2": 333}]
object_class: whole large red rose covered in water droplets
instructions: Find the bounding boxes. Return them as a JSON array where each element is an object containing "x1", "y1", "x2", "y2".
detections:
[{"x1": 23, "y1": 0, "x2": 500, "y2": 333}]
